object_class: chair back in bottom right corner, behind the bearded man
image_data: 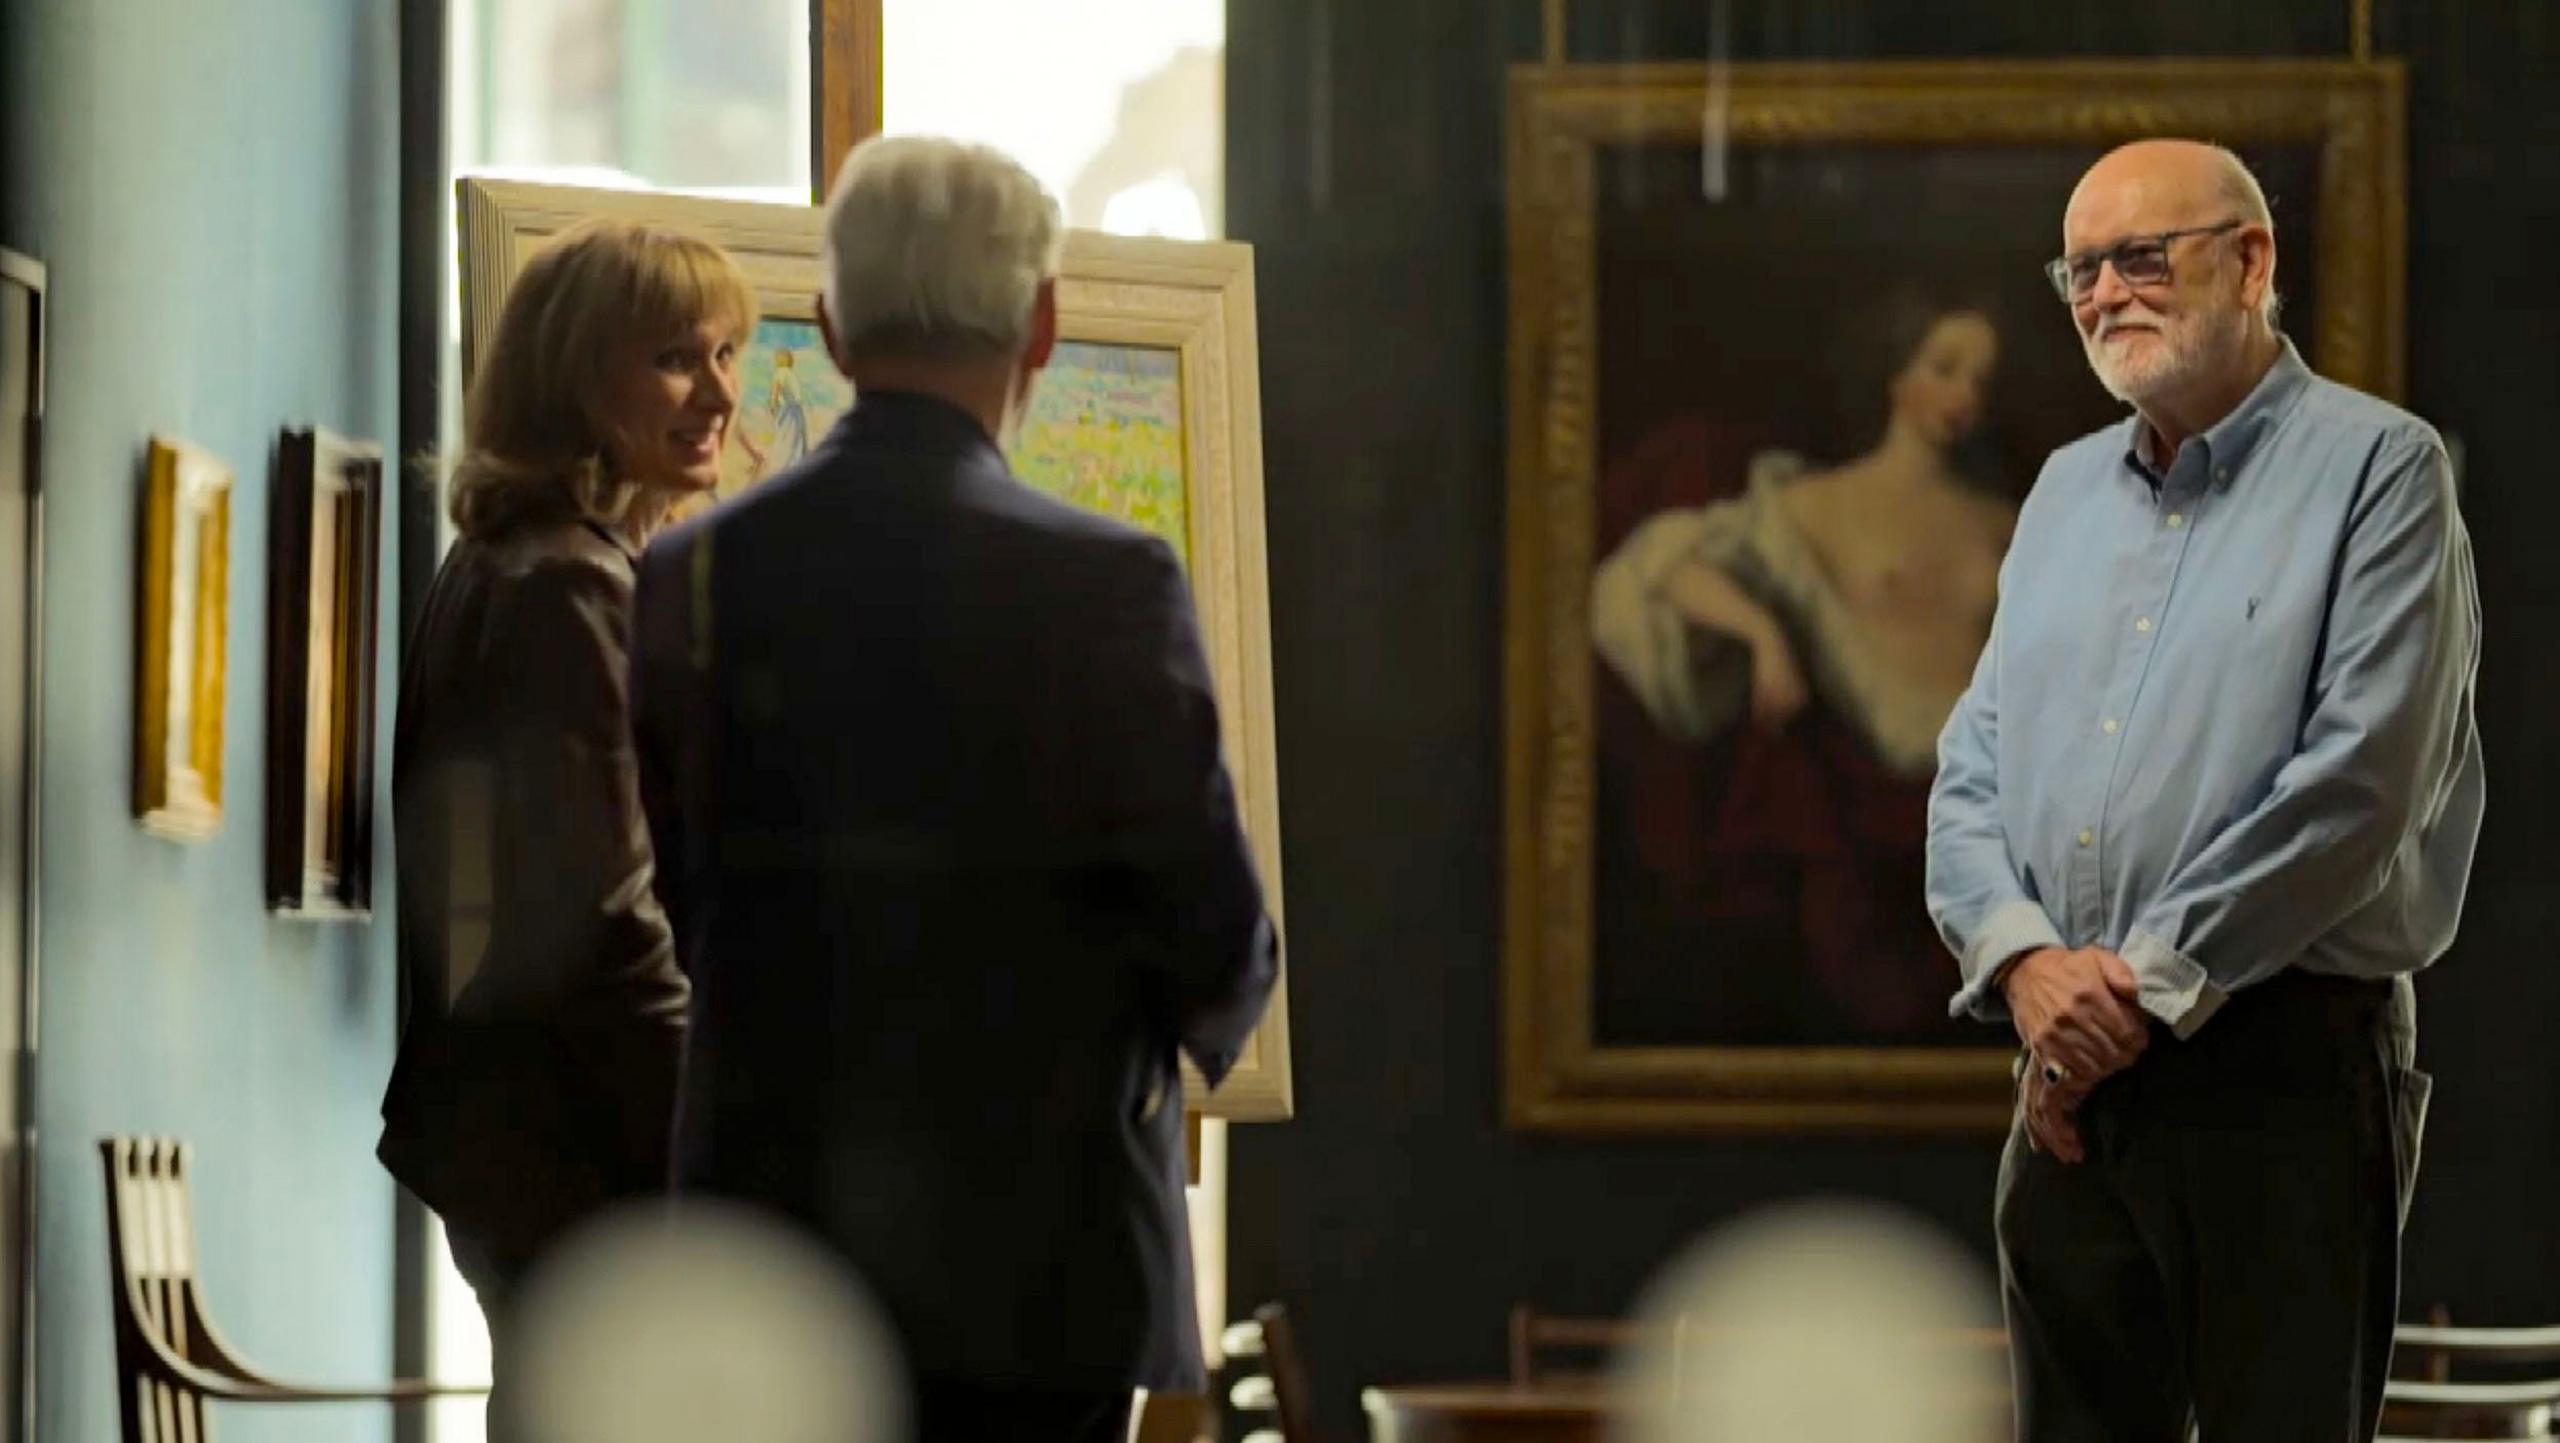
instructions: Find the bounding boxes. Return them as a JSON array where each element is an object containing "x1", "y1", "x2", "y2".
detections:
[{"x1": 2383, "y1": 1307, "x2": 2560, "y2": 1443}]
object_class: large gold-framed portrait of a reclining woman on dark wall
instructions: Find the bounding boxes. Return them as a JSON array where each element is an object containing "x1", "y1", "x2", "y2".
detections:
[{"x1": 1503, "y1": 61, "x2": 2406, "y2": 1133}]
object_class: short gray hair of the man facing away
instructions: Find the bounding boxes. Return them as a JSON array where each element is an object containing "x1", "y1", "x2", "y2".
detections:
[{"x1": 824, "y1": 136, "x2": 1065, "y2": 361}]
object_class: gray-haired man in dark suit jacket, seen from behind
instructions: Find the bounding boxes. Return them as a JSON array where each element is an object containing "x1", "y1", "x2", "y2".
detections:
[{"x1": 632, "y1": 138, "x2": 1277, "y2": 1440}]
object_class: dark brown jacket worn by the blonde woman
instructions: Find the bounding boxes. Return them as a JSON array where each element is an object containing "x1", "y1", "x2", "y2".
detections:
[{"x1": 379, "y1": 519, "x2": 686, "y2": 1266}]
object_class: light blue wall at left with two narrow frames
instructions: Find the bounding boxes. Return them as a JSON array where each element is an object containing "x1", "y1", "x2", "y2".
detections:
[{"x1": 0, "y1": 0, "x2": 399, "y2": 1443}]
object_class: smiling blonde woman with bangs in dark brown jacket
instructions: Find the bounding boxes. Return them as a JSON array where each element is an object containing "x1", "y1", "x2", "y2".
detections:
[{"x1": 379, "y1": 223, "x2": 755, "y2": 1423}]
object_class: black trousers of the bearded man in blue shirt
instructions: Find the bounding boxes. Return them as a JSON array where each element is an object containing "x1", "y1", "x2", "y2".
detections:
[{"x1": 1997, "y1": 972, "x2": 2427, "y2": 1443}]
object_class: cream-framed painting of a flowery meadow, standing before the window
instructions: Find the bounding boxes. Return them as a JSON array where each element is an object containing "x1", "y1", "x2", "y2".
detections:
[{"x1": 456, "y1": 179, "x2": 1293, "y2": 1121}]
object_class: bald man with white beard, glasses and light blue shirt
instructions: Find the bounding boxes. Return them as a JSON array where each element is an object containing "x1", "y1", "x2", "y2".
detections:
[{"x1": 1928, "y1": 141, "x2": 2483, "y2": 1443}]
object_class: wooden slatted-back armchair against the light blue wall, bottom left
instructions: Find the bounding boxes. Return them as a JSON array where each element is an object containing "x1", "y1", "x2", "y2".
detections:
[{"x1": 97, "y1": 1139, "x2": 489, "y2": 1443}]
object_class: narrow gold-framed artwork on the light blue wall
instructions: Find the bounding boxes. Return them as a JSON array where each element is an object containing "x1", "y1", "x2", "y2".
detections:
[{"x1": 133, "y1": 438, "x2": 230, "y2": 842}]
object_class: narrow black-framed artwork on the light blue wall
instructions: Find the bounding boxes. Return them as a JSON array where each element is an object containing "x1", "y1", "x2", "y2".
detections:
[{"x1": 266, "y1": 427, "x2": 381, "y2": 919}]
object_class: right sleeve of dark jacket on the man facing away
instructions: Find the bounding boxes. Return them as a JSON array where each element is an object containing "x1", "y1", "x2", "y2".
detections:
[{"x1": 1088, "y1": 537, "x2": 1280, "y2": 1087}]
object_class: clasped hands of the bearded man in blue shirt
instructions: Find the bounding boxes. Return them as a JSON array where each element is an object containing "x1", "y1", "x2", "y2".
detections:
[{"x1": 1999, "y1": 947, "x2": 2150, "y2": 1162}]
